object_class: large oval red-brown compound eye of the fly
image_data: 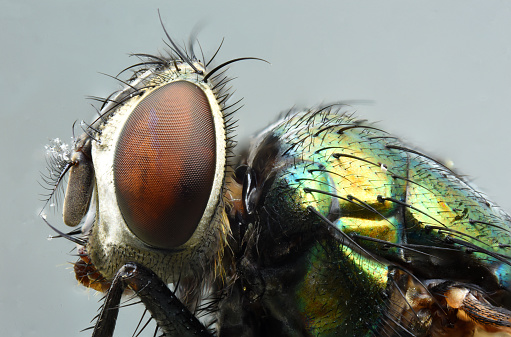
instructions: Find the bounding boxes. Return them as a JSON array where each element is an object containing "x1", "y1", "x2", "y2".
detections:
[{"x1": 114, "y1": 81, "x2": 216, "y2": 249}]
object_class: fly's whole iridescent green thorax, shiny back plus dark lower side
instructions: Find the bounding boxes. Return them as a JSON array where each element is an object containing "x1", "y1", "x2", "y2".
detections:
[{"x1": 239, "y1": 108, "x2": 511, "y2": 336}]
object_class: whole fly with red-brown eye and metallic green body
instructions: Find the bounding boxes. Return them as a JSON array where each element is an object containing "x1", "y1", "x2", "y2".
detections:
[{"x1": 41, "y1": 12, "x2": 511, "y2": 336}]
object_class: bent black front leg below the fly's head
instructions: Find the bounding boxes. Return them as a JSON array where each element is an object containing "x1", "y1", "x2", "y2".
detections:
[{"x1": 93, "y1": 262, "x2": 212, "y2": 337}]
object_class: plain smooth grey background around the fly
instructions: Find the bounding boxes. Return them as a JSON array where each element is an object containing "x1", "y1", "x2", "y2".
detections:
[{"x1": 0, "y1": 0, "x2": 511, "y2": 336}]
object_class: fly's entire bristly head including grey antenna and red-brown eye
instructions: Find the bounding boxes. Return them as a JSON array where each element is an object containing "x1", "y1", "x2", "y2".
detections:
[{"x1": 38, "y1": 21, "x2": 260, "y2": 291}]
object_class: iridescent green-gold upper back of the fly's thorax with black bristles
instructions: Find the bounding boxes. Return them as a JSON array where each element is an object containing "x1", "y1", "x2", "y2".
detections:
[{"x1": 274, "y1": 108, "x2": 511, "y2": 280}]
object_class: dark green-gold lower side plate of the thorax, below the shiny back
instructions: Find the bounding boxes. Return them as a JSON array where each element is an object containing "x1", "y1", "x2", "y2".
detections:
[{"x1": 296, "y1": 242, "x2": 387, "y2": 336}]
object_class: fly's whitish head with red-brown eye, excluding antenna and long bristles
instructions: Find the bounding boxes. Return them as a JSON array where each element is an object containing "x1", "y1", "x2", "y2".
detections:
[{"x1": 87, "y1": 64, "x2": 228, "y2": 282}]
